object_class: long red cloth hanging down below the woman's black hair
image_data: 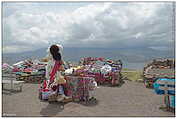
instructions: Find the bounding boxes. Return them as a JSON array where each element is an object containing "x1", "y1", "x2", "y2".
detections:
[{"x1": 50, "y1": 61, "x2": 61, "y2": 83}]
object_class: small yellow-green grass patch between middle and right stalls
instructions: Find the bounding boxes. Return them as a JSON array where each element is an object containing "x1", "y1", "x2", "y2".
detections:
[{"x1": 122, "y1": 69, "x2": 143, "y2": 81}]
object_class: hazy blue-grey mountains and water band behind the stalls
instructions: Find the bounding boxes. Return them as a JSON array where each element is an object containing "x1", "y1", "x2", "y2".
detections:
[{"x1": 3, "y1": 47, "x2": 175, "y2": 69}]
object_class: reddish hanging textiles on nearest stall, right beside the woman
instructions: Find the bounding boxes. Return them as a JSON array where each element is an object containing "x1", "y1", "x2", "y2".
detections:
[{"x1": 65, "y1": 76, "x2": 97, "y2": 101}]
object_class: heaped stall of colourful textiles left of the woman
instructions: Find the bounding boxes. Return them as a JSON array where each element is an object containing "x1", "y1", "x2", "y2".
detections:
[{"x1": 8, "y1": 60, "x2": 46, "y2": 82}]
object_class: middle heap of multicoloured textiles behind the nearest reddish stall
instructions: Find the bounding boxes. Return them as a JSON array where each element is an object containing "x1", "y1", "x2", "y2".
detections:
[{"x1": 65, "y1": 57, "x2": 122, "y2": 85}]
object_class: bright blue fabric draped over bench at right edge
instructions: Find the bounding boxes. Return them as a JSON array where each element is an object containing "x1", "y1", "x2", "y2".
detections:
[{"x1": 153, "y1": 78, "x2": 175, "y2": 95}]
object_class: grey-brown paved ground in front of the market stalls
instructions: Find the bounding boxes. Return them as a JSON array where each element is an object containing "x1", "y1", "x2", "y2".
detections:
[{"x1": 2, "y1": 81, "x2": 174, "y2": 117}]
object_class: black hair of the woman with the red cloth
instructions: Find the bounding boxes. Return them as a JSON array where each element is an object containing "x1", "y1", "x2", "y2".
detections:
[{"x1": 50, "y1": 45, "x2": 61, "y2": 61}]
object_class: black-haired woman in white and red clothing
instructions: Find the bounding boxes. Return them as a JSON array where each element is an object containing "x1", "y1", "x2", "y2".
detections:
[{"x1": 46, "y1": 45, "x2": 68, "y2": 101}]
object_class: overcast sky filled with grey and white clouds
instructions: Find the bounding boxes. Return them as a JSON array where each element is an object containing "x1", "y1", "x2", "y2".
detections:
[{"x1": 2, "y1": 2, "x2": 174, "y2": 53}]
